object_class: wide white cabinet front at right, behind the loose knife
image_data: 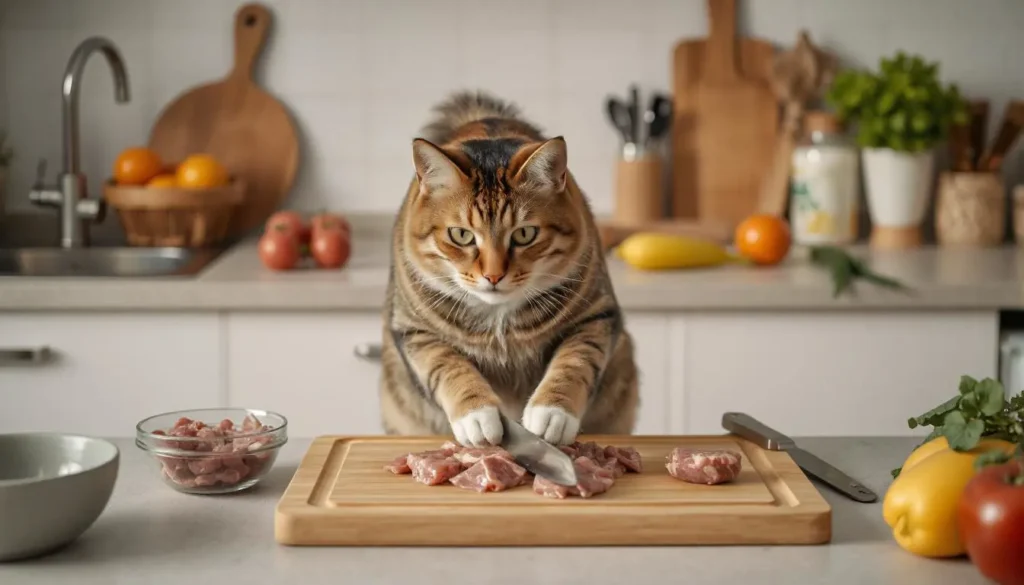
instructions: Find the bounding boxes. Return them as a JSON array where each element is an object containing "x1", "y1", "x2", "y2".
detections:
[{"x1": 672, "y1": 311, "x2": 998, "y2": 435}]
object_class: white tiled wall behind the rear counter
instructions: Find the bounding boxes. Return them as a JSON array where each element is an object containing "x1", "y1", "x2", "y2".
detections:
[{"x1": 0, "y1": 0, "x2": 1024, "y2": 217}]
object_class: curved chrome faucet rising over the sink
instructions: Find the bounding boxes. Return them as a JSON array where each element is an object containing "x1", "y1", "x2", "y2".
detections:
[{"x1": 29, "y1": 37, "x2": 129, "y2": 248}]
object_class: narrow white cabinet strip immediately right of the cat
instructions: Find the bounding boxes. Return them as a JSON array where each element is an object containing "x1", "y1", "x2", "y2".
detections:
[{"x1": 626, "y1": 312, "x2": 670, "y2": 434}]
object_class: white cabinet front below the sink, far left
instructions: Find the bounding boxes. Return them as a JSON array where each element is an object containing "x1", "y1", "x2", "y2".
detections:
[{"x1": 0, "y1": 312, "x2": 223, "y2": 436}]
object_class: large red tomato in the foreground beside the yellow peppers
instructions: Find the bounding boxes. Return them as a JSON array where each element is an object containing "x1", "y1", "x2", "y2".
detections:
[{"x1": 956, "y1": 458, "x2": 1024, "y2": 585}]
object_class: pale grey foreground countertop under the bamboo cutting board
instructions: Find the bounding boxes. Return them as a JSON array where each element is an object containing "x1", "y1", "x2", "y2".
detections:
[{"x1": 0, "y1": 437, "x2": 987, "y2": 585}]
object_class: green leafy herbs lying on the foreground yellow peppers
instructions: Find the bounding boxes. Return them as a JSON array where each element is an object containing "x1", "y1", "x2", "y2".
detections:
[{"x1": 892, "y1": 376, "x2": 1024, "y2": 477}]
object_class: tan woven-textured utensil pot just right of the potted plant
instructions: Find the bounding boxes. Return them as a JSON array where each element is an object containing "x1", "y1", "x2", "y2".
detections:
[{"x1": 935, "y1": 171, "x2": 1007, "y2": 247}]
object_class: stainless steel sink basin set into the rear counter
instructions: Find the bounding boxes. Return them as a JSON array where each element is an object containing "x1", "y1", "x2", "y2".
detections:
[{"x1": 0, "y1": 247, "x2": 221, "y2": 277}]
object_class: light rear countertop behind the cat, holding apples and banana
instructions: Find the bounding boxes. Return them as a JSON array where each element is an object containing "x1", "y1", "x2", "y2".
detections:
[{"x1": 0, "y1": 214, "x2": 1024, "y2": 310}]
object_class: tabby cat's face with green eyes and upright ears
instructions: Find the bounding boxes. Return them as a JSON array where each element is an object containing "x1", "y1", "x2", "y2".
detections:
[{"x1": 409, "y1": 138, "x2": 581, "y2": 305}]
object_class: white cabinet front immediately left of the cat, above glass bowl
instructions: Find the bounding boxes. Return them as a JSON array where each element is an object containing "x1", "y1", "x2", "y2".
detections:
[{"x1": 227, "y1": 312, "x2": 383, "y2": 437}]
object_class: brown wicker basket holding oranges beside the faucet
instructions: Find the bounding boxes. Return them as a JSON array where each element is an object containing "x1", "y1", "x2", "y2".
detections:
[{"x1": 103, "y1": 177, "x2": 245, "y2": 248}]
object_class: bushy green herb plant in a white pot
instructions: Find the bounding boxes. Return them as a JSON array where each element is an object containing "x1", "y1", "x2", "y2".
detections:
[{"x1": 825, "y1": 51, "x2": 968, "y2": 247}]
